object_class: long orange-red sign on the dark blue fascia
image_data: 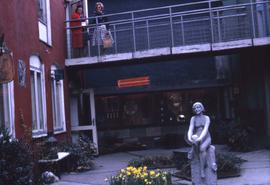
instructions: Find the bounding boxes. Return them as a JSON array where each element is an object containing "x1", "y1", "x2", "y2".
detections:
[{"x1": 117, "y1": 76, "x2": 150, "y2": 88}]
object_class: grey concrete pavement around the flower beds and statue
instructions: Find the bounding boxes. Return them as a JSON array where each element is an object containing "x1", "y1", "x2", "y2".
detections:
[{"x1": 54, "y1": 147, "x2": 270, "y2": 185}]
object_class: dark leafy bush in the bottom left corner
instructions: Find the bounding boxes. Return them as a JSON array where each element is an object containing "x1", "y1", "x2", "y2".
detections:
[{"x1": 0, "y1": 129, "x2": 33, "y2": 185}]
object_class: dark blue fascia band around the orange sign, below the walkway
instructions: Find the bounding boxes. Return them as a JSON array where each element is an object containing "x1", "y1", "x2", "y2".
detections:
[{"x1": 83, "y1": 57, "x2": 229, "y2": 95}]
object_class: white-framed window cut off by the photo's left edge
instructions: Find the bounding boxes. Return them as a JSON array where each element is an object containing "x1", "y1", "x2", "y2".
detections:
[{"x1": 0, "y1": 82, "x2": 15, "y2": 137}]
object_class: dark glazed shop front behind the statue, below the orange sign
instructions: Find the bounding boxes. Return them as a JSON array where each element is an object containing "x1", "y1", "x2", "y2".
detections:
[{"x1": 96, "y1": 88, "x2": 223, "y2": 151}]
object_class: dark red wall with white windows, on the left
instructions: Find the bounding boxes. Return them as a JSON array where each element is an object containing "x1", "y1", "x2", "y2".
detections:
[{"x1": 0, "y1": 0, "x2": 70, "y2": 141}]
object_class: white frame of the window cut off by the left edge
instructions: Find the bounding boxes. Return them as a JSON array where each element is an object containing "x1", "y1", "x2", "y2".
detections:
[{"x1": 2, "y1": 81, "x2": 16, "y2": 138}]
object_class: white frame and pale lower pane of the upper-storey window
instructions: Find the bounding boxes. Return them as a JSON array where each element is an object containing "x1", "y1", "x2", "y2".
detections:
[{"x1": 38, "y1": 0, "x2": 52, "y2": 46}]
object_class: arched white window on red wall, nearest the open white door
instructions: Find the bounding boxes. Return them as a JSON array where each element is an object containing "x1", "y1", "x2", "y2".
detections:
[{"x1": 51, "y1": 66, "x2": 66, "y2": 133}]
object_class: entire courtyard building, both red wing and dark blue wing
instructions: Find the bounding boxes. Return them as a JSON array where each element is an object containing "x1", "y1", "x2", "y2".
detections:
[{"x1": 0, "y1": 0, "x2": 270, "y2": 154}]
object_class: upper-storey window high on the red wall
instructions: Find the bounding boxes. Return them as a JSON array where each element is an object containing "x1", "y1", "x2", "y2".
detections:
[{"x1": 37, "y1": 0, "x2": 52, "y2": 45}]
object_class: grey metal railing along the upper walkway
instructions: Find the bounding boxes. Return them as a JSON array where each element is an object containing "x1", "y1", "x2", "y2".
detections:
[{"x1": 66, "y1": 0, "x2": 270, "y2": 61}]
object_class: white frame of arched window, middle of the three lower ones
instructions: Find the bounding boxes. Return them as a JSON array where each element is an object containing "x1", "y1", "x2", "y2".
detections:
[{"x1": 30, "y1": 56, "x2": 47, "y2": 138}]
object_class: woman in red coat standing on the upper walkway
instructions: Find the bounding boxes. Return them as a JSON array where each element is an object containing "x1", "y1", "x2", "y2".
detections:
[{"x1": 70, "y1": 5, "x2": 84, "y2": 55}]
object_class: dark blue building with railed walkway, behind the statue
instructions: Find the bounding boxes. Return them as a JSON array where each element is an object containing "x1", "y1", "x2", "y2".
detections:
[{"x1": 66, "y1": 0, "x2": 270, "y2": 153}]
